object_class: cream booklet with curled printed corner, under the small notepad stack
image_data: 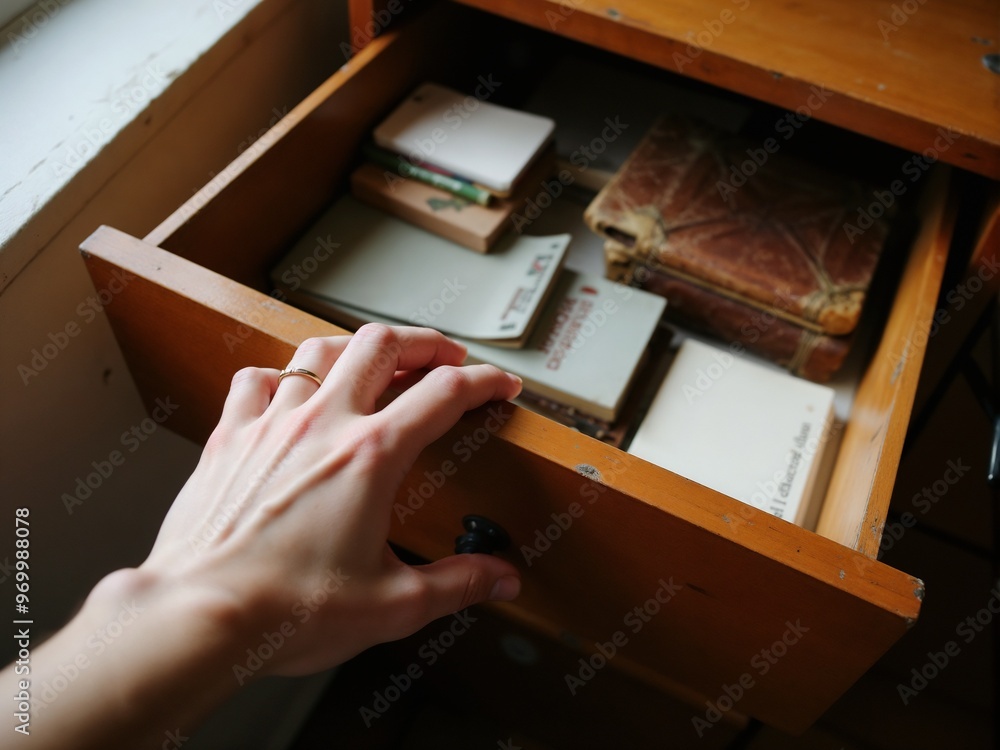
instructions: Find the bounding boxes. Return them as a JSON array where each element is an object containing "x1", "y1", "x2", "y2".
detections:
[{"x1": 271, "y1": 195, "x2": 570, "y2": 348}]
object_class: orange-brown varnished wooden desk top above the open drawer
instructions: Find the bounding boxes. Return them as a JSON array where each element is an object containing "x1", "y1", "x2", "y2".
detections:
[{"x1": 450, "y1": 0, "x2": 1000, "y2": 179}]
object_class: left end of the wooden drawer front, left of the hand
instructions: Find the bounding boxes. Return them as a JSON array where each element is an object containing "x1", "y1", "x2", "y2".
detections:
[{"x1": 84, "y1": 228, "x2": 346, "y2": 442}]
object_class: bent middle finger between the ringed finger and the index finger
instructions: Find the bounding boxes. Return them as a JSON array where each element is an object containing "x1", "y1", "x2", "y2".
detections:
[{"x1": 329, "y1": 324, "x2": 465, "y2": 414}]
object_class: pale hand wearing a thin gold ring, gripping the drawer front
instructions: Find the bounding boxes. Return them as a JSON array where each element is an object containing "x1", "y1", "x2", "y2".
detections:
[{"x1": 141, "y1": 325, "x2": 520, "y2": 674}]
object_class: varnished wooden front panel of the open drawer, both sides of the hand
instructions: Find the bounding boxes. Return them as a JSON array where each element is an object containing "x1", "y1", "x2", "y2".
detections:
[{"x1": 84, "y1": 228, "x2": 922, "y2": 730}]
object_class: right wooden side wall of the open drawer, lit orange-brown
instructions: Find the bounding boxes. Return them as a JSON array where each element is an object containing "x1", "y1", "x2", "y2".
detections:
[{"x1": 816, "y1": 169, "x2": 956, "y2": 557}]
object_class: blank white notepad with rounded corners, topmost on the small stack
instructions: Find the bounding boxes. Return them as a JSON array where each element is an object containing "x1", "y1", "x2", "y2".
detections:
[{"x1": 373, "y1": 83, "x2": 555, "y2": 194}]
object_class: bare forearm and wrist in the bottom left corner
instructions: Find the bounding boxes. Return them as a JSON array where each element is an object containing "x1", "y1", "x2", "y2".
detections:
[{"x1": 0, "y1": 571, "x2": 250, "y2": 748}]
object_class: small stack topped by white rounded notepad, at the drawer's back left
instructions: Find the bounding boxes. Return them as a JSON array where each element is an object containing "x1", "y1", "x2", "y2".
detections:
[{"x1": 351, "y1": 83, "x2": 556, "y2": 252}]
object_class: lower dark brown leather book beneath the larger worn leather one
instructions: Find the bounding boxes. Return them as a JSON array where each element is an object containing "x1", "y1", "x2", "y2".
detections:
[{"x1": 604, "y1": 241, "x2": 851, "y2": 383}]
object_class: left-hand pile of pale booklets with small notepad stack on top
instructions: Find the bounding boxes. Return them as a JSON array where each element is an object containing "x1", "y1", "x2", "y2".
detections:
[{"x1": 272, "y1": 84, "x2": 666, "y2": 424}]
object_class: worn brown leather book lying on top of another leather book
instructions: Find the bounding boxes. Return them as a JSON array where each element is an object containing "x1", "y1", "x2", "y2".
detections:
[{"x1": 584, "y1": 117, "x2": 888, "y2": 335}]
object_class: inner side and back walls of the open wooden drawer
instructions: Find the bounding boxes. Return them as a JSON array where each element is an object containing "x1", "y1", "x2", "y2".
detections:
[{"x1": 145, "y1": 1, "x2": 950, "y2": 557}]
